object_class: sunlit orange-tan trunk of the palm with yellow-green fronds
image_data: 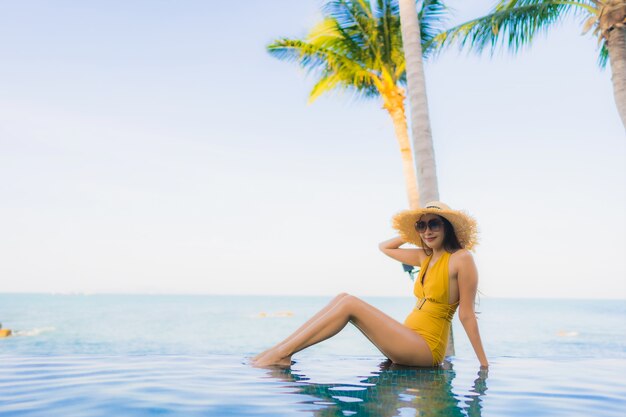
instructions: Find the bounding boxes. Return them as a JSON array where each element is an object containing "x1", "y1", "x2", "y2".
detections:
[{"x1": 381, "y1": 89, "x2": 419, "y2": 208}]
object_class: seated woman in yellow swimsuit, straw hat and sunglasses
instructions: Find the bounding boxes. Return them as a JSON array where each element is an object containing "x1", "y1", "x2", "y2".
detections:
[{"x1": 252, "y1": 201, "x2": 488, "y2": 367}]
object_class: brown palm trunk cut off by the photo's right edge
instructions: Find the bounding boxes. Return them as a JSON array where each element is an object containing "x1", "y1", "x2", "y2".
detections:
[{"x1": 607, "y1": 26, "x2": 626, "y2": 128}]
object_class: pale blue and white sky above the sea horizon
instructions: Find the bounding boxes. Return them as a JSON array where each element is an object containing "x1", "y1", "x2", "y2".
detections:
[{"x1": 0, "y1": 0, "x2": 626, "y2": 299}]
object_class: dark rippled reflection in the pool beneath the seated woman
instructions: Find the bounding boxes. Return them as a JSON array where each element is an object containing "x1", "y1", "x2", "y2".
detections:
[{"x1": 272, "y1": 361, "x2": 487, "y2": 417}]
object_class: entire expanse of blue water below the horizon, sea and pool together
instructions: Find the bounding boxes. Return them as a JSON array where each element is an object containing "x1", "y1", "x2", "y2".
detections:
[{"x1": 0, "y1": 294, "x2": 626, "y2": 417}]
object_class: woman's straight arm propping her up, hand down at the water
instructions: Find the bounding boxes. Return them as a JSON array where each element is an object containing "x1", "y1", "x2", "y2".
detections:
[{"x1": 457, "y1": 250, "x2": 489, "y2": 367}]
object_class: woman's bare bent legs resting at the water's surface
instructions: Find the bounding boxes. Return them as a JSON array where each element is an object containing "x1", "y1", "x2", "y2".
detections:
[{"x1": 255, "y1": 295, "x2": 433, "y2": 366}]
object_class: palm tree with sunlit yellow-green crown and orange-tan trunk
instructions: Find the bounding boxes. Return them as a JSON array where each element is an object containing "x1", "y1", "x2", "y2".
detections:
[{"x1": 267, "y1": 0, "x2": 446, "y2": 208}]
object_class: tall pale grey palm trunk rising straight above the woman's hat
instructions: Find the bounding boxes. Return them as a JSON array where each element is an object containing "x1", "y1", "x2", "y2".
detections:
[{"x1": 399, "y1": 0, "x2": 439, "y2": 205}]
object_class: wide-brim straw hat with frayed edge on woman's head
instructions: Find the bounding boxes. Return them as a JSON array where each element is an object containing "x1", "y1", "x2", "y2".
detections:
[{"x1": 392, "y1": 201, "x2": 478, "y2": 249}]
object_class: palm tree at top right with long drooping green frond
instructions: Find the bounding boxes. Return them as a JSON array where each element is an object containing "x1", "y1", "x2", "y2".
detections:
[{"x1": 427, "y1": 0, "x2": 626, "y2": 127}]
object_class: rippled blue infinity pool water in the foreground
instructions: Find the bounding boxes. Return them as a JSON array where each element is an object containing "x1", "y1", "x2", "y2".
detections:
[{"x1": 0, "y1": 355, "x2": 626, "y2": 417}]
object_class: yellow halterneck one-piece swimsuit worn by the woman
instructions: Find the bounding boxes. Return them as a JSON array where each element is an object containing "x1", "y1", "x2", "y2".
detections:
[{"x1": 404, "y1": 252, "x2": 459, "y2": 365}]
